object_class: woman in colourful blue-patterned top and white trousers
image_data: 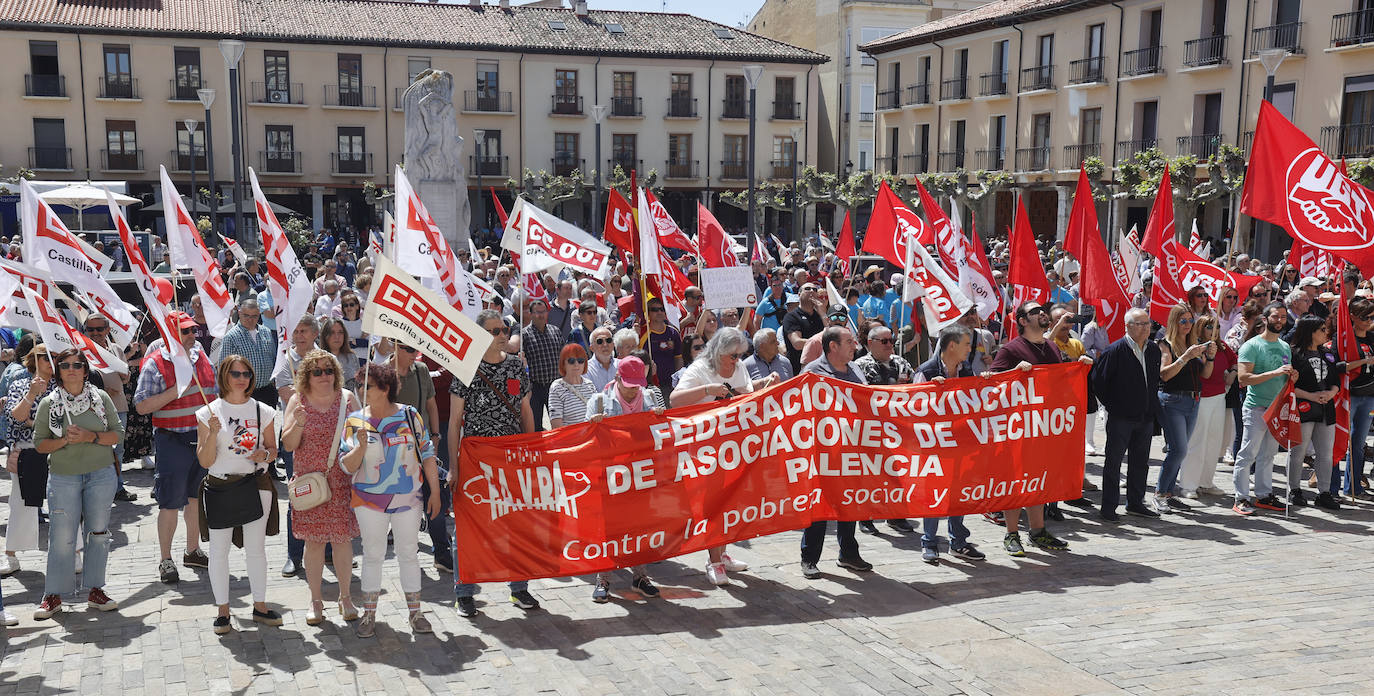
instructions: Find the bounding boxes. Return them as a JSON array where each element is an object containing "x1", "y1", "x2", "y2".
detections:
[{"x1": 339, "y1": 364, "x2": 444, "y2": 638}]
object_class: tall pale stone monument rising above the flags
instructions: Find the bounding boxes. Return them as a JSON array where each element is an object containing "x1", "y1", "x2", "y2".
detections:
[{"x1": 403, "y1": 70, "x2": 471, "y2": 253}]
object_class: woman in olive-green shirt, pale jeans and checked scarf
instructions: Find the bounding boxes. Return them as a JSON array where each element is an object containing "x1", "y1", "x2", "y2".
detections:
[{"x1": 33, "y1": 349, "x2": 124, "y2": 619}]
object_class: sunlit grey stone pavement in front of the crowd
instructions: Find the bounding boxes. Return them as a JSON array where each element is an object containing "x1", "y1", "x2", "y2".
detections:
[{"x1": 0, "y1": 431, "x2": 1374, "y2": 696}]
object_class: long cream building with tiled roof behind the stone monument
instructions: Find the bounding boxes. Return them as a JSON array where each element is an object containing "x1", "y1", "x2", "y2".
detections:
[{"x1": 0, "y1": 0, "x2": 826, "y2": 240}]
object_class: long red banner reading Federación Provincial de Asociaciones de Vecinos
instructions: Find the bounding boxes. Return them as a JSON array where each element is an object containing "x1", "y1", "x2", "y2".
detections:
[{"x1": 453, "y1": 362, "x2": 1087, "y2": 582}]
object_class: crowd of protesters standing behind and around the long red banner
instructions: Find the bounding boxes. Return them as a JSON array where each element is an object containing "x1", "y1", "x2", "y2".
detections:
[{"x1": 0, "y1": 221, "x2": 1374, "y2": 637}]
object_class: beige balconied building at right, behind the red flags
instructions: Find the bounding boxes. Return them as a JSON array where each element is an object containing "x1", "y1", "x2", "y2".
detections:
[{"x1": 864, "y1": 0, "x2": 1374, "y2": 258}]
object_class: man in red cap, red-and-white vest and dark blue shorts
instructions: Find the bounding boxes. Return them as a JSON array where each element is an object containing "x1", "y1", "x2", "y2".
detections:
[{"x1": 133, "y1": 312, "x2": 217, "y2": 583}]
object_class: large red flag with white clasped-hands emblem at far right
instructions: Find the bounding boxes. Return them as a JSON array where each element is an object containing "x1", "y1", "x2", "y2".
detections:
[{"x1": 1241, "y1": 102, "x2": 1374, "y2": 276}]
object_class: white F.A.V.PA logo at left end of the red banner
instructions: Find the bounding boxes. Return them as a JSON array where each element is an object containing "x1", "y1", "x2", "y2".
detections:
[{"x1": 463, "y1": 449, "x2": 592, "y2": 520}]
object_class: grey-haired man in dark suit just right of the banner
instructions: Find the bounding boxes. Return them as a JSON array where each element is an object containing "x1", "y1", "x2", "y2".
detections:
[{"x1": 1090, "y1": 309, "x2": 1161, "y2": 522}]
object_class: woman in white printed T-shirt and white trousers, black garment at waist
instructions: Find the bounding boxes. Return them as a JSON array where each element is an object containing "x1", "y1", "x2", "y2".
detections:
[{"x1": 195, "y1": 356, "x2": 282, "y2": 634}]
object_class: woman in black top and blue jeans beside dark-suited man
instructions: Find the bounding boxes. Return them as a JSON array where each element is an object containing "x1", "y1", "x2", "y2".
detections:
[{"x1": 1154, "y1": 304, "x2": 1216, "y2": 512}]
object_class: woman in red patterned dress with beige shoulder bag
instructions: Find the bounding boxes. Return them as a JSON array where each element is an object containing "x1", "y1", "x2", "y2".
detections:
[{"x1": 282, "y1": 349, "x2": 359, "y2": 626}]
